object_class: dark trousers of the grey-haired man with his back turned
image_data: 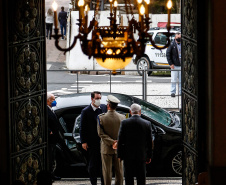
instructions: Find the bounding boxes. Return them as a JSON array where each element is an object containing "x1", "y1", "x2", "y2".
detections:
[{"x1": 124, "y1": 159, "x2": 146, "y2": 185}]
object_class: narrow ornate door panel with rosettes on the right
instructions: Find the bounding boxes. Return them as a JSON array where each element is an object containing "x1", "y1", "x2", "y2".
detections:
[{"x1": 181, "y1": 0, "x2": 198, "y2": 185}]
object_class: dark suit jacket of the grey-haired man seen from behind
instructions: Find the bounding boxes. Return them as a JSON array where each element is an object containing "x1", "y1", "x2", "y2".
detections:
[{"x1": 117, "y1": 115, "x2": 152, "y2": 161}]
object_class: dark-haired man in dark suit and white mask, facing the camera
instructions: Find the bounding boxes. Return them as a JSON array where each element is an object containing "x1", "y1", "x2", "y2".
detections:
[{"x1": 80, "y1": 91, "x2": 107, "y2": 185}]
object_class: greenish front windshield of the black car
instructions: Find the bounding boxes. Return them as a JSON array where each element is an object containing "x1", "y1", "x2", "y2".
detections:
[{"x1": 134, "y1": 97, "x2": 171, "y2": 126}]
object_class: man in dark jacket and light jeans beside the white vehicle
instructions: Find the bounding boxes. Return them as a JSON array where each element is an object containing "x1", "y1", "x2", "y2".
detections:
[{"x1": 166, "y1": 32, "x2": 181, "y2": 97}]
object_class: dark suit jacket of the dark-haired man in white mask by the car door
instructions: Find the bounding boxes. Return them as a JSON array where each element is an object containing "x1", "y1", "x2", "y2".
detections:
[{"x1": 80, "y1": 104, "x2": 107, "y2": 147}]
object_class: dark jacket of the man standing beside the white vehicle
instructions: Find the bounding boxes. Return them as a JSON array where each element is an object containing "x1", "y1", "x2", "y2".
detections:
[{"x1": 166, "y1": 40, "x2": 181, "y2": 66}]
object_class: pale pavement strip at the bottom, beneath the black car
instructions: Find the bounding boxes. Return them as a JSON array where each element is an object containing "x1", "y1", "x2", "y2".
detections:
[{"x1": 53, "y1": 177, "x2": 182, "y2": 185}]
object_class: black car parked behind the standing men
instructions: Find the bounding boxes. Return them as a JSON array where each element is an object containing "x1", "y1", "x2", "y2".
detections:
[{"x1": 51, "y1": 93, "x2": 182, "y2": 177}]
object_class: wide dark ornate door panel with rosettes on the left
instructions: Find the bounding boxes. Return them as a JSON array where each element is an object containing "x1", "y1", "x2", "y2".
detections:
[{"x1": 2, "y1": 0, "x2": 47, "y2": 184}]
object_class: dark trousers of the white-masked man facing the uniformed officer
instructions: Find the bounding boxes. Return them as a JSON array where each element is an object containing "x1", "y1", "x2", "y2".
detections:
[{"x1": 88, "y1": 146, "x2": 104, "y2": 185}]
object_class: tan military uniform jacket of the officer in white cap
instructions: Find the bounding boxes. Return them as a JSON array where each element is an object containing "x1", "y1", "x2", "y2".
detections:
[{"x1": 97, "y1": 110, "x2": 126, "y2": 154}]
